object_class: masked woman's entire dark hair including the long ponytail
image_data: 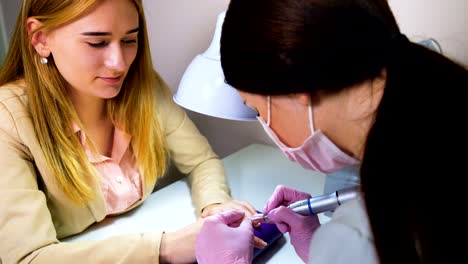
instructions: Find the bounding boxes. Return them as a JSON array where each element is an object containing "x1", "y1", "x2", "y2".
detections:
[{"x1": 221, "y1": 0, "x2": 468, "y2": 263}]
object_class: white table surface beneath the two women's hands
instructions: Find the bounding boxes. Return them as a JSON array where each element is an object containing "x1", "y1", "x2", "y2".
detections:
[{"x1": 63, "y1": 144, "x2": 328, "y2": 264}]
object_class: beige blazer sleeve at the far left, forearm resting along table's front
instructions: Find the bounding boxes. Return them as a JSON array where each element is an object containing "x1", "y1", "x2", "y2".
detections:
[{"x1": 0, "y1": 102, "x2": 161, "y2": 264}]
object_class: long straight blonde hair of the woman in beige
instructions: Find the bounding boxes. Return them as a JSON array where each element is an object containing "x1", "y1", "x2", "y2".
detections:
[{"x1": 0, "y1": 0, "x2": 167, "y2": 204}]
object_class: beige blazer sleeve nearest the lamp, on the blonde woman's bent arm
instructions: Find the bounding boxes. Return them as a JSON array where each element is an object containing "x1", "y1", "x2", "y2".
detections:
[{"x1": 158, "y1": 78, "x2": 232, "y2": 213}]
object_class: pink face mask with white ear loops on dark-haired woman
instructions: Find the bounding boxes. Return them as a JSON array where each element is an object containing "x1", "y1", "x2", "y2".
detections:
[{"x1": 257, "y1": 96, "x2": 359, "y2": 173}]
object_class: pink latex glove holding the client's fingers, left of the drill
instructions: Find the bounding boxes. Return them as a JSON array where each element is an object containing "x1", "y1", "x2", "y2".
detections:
[{"x1": 195, "y1": 211, "x2": 254, "y2": 264}]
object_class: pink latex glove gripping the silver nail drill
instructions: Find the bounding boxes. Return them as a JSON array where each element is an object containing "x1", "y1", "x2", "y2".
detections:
[{"x1": 263, "y1": 185, "x2": 320, "y2": 263}]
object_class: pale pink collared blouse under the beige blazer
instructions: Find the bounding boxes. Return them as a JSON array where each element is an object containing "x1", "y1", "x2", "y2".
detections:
[{"x1": 73, "y1": 124, "x2": 143, "y2": 215}]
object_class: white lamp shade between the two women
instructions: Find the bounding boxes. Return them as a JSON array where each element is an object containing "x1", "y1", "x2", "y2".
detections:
[{"x1": 173, "y1": 12, "x2": 257, "y2": 121}]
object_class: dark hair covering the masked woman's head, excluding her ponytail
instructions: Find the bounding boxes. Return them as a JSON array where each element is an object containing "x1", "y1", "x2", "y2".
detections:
[{"x1": 221, "y1": 0, "x2": 399, "y2": 95}]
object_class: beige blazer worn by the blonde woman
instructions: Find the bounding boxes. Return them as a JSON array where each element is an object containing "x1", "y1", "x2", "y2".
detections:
[{"x1": 0, "y1": 82, "x2": 231, "y2": 264}]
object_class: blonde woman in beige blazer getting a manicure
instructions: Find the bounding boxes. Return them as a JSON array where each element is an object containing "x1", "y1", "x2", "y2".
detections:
[{"x1": 0, "y1": 0, "x2": 255, "y2": 264}]
